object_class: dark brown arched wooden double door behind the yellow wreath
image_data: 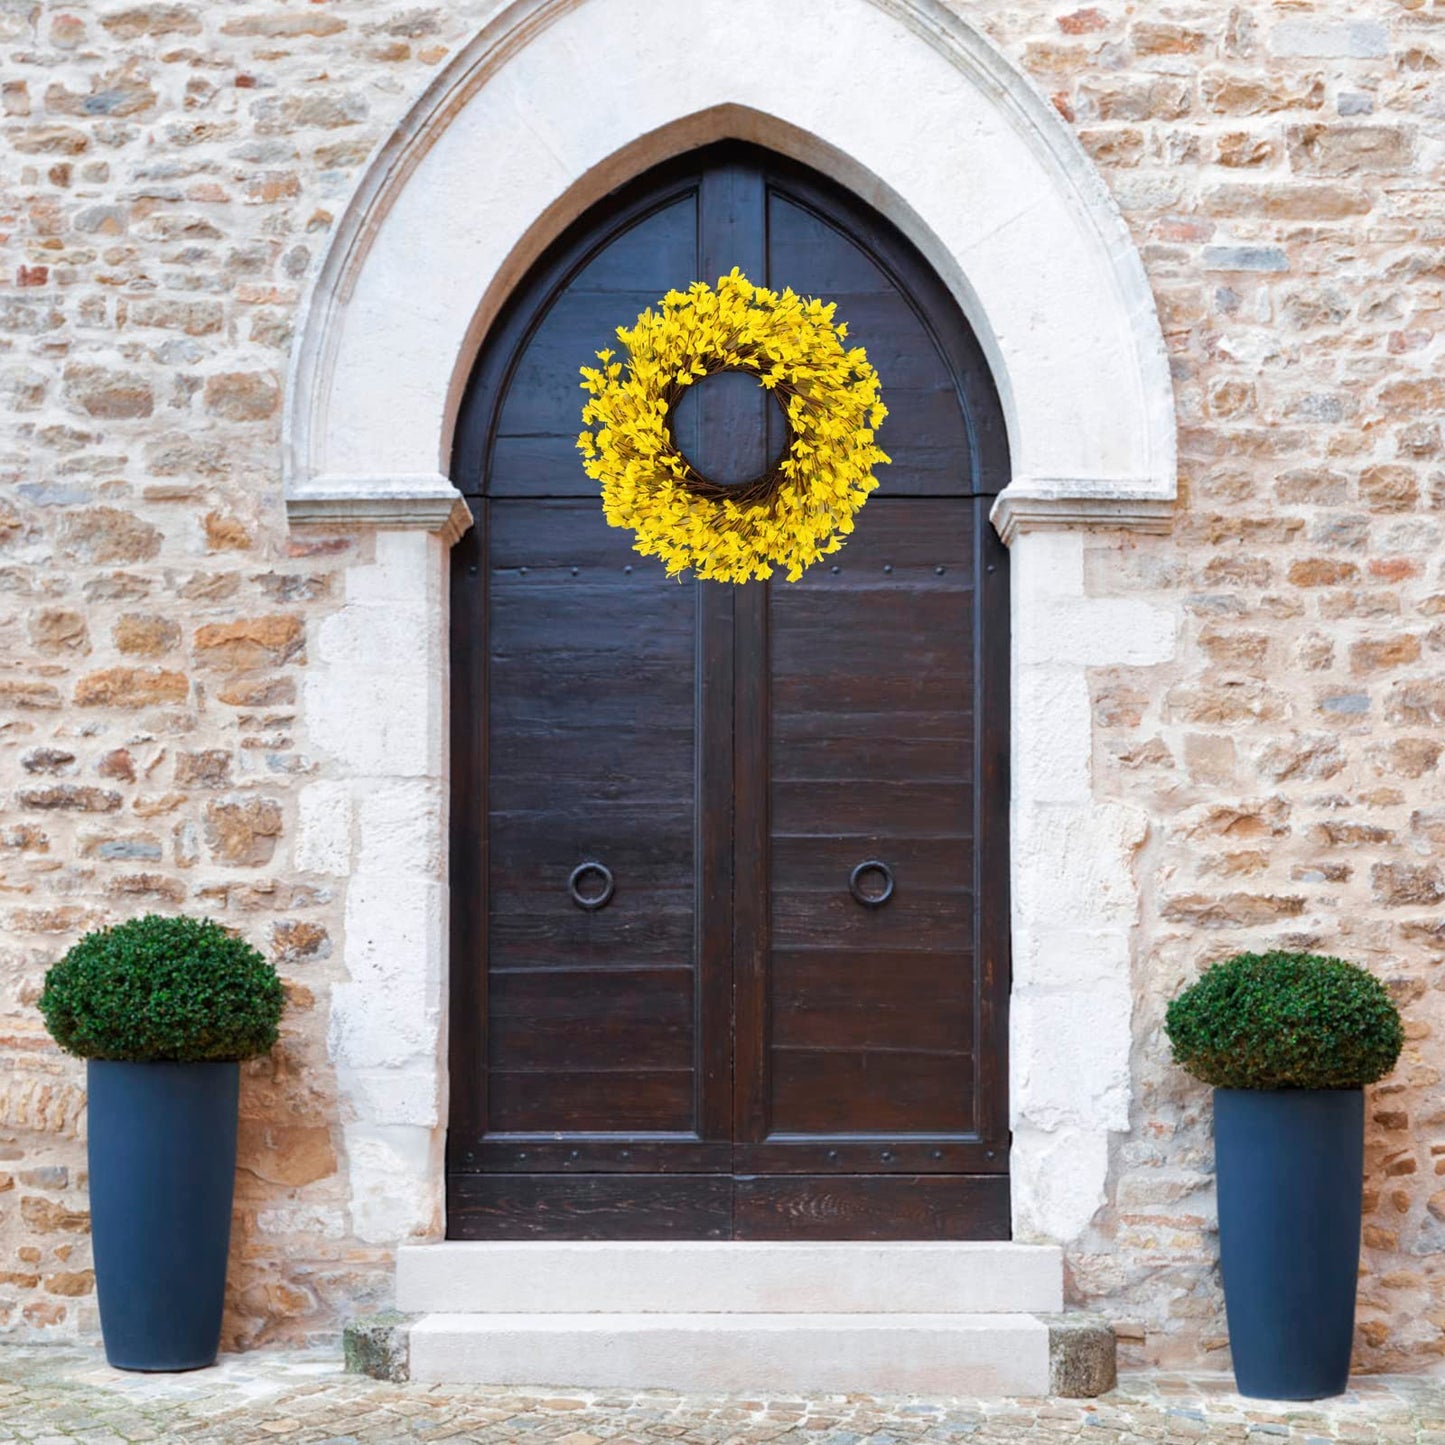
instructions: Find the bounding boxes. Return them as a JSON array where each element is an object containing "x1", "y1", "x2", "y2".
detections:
[{"x1": 448, "y1": 145, "x2": 1009, "y2": 1238}]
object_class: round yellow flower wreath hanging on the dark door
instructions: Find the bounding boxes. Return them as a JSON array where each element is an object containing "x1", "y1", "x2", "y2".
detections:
[{"x1": 577, "y1": 267, "x2": 889, "y2": 582}]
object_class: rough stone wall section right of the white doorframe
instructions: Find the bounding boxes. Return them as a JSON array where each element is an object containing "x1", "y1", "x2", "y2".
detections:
[{"x1": 991, "y1": 0, "x2": 1445, "y2": 1370}]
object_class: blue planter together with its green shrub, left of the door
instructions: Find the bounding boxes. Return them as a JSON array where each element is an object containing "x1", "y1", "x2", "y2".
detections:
[{"x1": 39, "y1": 915, "x2": 285, "y2": 1370}]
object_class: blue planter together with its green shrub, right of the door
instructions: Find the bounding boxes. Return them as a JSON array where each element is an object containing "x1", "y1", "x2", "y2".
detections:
[{"x1": 1165, "y1": 952, "x2": 1405, "y2": 1400}]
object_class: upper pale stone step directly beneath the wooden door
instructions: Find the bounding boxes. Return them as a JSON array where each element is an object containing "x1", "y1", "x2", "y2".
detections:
[{"x1": 396, "y1": 1240, "x2": 1064, "y2": 1315}]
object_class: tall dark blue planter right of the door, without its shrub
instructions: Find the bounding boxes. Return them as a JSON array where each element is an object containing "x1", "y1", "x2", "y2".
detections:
[{"x1": 1214, "y1": 1088, "x2": 1364, "y2": 1400}]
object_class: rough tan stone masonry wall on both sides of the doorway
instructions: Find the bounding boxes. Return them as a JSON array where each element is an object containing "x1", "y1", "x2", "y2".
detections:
[{"x1": 0, "y1": 0, "x2": 1445, "y2": 1368}]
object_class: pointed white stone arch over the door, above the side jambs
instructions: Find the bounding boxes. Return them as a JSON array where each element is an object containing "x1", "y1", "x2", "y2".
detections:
[{"x1": 286, "y1": 0, "x2": 1175, "y2": 537}]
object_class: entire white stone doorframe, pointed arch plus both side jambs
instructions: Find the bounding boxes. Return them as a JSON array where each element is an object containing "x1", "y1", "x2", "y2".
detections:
[{"x1": 285, "y1": 0, "x2": 1175, "y2": 1244}]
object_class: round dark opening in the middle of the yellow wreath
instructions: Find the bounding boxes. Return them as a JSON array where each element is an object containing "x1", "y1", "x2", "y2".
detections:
[{"x1": 668, "y1": 370, "x2": 792, "y2": 488}]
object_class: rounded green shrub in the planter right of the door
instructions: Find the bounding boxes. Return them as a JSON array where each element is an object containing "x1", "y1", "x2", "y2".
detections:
[{"x1": 1165, "y1": 952, "x2": 1405, "y2": 1088}]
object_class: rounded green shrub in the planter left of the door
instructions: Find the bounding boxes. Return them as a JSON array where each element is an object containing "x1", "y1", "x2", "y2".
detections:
[{"x1": 40, "y1": 913, "x2": 282, "y2": 1064}]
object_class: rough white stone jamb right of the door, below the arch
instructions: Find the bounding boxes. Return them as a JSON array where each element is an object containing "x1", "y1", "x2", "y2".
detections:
[{"x1": 1009, "y1": 526, "x2": 1176, "y2": 1243}]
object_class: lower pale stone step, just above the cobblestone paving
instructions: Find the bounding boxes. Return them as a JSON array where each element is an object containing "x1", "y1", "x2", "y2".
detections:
[{"x1": 410, "y1": 1314, "x2": 1049, "y2": 1396}]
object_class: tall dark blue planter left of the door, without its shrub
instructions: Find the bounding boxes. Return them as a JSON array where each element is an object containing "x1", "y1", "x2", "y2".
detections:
[{"x1": 88, "y1": 1059, "x2": 240, "y2": 1370}]
